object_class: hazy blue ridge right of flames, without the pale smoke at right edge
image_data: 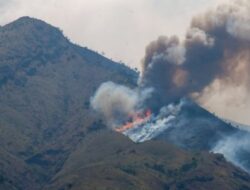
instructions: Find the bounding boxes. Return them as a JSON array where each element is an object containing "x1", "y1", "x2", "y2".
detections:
[{"x1": 127, "y1": 99, "x2": 237, "y2": 150}]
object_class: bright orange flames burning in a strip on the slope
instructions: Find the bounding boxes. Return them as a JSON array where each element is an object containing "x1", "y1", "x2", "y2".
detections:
[{"x1": 115, "y1": 110, "x2": 152, "y2": 133}]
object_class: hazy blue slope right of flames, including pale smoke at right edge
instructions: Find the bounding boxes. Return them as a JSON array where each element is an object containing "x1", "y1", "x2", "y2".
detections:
[{"x1": 124, "y1": 99, "x2": 250, "y2": 172}]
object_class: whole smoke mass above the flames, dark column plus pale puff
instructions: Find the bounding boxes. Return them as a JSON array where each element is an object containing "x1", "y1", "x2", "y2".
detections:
[{"x1": 92, "y1": 0, "x2": 250, "y2": 126}]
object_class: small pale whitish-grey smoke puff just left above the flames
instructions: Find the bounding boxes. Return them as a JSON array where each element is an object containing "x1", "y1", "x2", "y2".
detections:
[{"x1": 91, "y1": 82, "x2": 152, "y2": 128}]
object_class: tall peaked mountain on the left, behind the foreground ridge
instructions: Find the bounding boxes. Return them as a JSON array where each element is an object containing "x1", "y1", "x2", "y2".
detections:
[{"x1": 0, "y1": 17, "x2": 137, "y2": 189}]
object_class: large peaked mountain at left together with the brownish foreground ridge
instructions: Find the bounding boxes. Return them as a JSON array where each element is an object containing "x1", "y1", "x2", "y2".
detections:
[{"x1": 0, "y1": 17, "x2": 250, "y2": 190}]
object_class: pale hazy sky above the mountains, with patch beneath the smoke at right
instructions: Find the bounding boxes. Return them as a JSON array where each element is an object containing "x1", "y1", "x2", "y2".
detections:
[{"x1": 0, "y1": 0, "x2": 250, "y2": 124}]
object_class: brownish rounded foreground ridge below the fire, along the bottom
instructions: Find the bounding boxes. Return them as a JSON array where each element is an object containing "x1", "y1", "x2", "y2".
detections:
[{"x1": 45, "y1": 131, "x2": 250, "y2": 190}]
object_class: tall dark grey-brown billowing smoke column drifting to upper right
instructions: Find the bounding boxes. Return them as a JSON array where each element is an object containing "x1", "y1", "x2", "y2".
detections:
[{"x1": 140, "y1": 1, "x2": 250, "y2": 110}]
